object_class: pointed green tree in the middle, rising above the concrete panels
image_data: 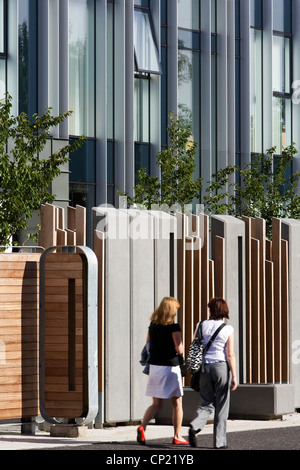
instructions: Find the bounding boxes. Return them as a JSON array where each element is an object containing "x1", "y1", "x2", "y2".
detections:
[{"x1": 121, "y1": 113, "x2": 202, "y2": 209}]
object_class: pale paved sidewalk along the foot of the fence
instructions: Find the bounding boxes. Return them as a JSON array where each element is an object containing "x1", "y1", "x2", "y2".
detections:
[{"x1": 0, "y1": 413, "x2": 300, "y2": 451}]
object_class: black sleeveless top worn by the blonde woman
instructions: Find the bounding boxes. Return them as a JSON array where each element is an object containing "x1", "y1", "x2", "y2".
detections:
[{"x1": 149, "y1": 322, "x2": 181, "y2": 366}]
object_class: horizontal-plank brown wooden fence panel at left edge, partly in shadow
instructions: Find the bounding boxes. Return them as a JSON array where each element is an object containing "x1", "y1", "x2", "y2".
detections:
[{"x1": 0, "y1": 253, "x2": 40, "y2": 419}]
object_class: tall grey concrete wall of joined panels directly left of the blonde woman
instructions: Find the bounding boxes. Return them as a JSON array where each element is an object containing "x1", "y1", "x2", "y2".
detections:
[{"x1": 93, "y1": 207, "x2": 176, "y2": 422}]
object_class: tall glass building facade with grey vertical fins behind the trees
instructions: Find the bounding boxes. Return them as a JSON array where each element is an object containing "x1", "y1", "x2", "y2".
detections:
[{"x1": 0, "y1": 0, "x2": 300, "y2": 241}]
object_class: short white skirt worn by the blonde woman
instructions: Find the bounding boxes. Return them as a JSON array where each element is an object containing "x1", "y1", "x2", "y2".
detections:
[{"x1": 146, "y1": 364, "x2": 183, "y2": 398}]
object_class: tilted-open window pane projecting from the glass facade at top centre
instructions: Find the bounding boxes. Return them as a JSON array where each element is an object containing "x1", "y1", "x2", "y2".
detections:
[{"x1": 134, "y1": 9, "x2": 161, "y2": 74}]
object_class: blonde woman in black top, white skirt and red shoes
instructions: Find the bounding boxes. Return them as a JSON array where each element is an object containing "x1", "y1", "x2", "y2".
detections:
[{"x1": 137, "y1": 297, "x2": 189, "y2": 445}]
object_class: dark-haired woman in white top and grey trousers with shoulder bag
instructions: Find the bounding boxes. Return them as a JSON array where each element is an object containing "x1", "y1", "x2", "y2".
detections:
[{"x1": 189, "y1": 298, "x2": 237, "y2": 449}]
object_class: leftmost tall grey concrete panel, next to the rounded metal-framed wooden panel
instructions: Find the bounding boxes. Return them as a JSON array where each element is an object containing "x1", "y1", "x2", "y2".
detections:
[{"x1": 93, "y1": 207, "x2": 131, "y2": 422}]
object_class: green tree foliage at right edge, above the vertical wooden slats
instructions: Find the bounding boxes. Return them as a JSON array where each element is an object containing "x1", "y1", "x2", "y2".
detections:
[{"x1": 204, "y1": 143, "x2": 300, "y2": 238}]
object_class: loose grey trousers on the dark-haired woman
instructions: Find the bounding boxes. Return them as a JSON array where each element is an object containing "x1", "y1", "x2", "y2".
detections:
[{"x1": 190, "y1": 362, "x2": 230, "y2": 447}]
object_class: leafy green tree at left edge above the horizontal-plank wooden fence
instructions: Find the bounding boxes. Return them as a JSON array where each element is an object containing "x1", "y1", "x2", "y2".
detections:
[{"x1": 0, "y1": 95, "x2": 85, "y2": 246}]
